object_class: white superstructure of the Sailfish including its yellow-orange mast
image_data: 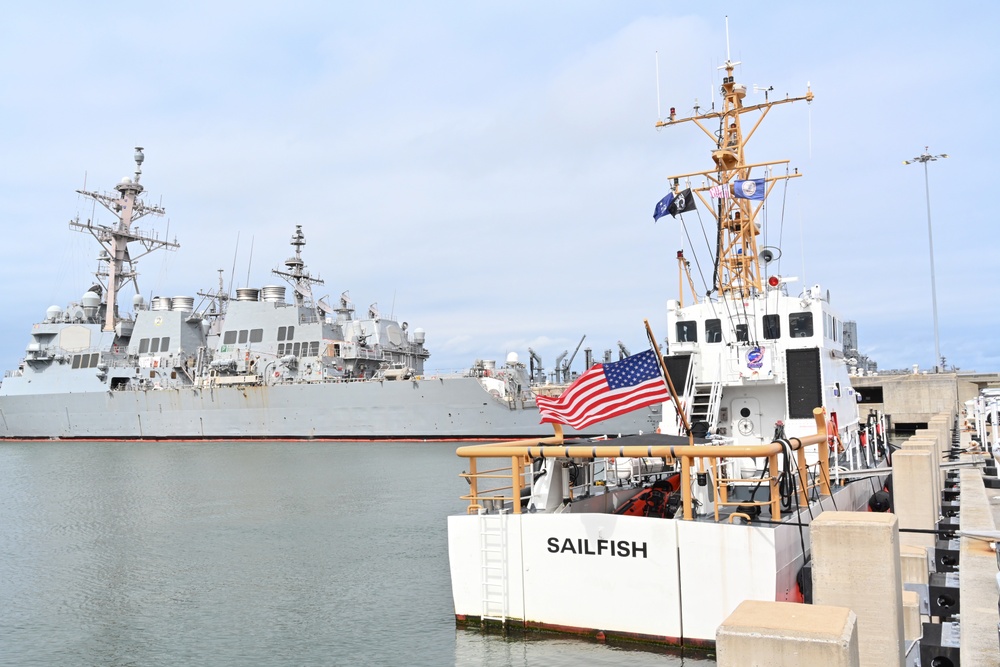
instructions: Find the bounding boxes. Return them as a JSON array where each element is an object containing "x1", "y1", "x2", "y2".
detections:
[{"x1": 657, "y1": 60, "x2": 858, "y2": 470}]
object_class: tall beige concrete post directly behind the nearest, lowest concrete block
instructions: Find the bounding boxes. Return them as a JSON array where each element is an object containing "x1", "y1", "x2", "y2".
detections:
[{"x1": 802, "y1": 516, "x2": 908, "y2": 667}]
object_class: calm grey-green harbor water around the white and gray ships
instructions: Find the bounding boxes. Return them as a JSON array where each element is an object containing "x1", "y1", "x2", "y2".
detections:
[{"x1": 0, "y1": 442, "x2": 710, "y2": 666}]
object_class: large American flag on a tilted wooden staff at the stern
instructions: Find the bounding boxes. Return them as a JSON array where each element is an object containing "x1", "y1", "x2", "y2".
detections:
[{"x1": 535, "y1": 350, "x2": 670, "y2": 429}]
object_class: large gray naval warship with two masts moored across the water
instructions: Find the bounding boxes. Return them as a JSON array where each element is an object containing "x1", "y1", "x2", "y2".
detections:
[{"x1": 0, "y1": 152, "x2": 661, "y2": 440}]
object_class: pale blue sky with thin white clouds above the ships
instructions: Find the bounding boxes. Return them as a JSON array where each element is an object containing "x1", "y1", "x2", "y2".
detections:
[{"x1": 0, "y1": 0, "x2": 1000, "y2": 372}]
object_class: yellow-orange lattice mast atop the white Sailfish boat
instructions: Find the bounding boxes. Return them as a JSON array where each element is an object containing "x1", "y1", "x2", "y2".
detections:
[{"x1": 656, "y1": 60, "x2": 813, "y2": 298}]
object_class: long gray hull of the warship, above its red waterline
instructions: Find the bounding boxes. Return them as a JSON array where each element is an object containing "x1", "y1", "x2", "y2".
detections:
[{"x1": 0, "y1": 377, "x2": 661, "y2": 440}]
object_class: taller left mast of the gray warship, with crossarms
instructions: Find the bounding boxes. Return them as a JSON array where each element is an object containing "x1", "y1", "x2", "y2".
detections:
[{"x1": 69, "y1": 146, "x2": 180, "y2": 331}]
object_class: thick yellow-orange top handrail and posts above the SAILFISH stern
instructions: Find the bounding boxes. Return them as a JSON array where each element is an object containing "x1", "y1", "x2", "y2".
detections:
[{"x1": 455, "y1": 408, "x2": 830, "y2": 520}]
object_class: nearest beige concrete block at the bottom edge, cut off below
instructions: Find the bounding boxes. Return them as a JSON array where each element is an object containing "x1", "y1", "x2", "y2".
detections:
[{"x1": 715, "y1": 600, "x2": 863, "y2": 667}]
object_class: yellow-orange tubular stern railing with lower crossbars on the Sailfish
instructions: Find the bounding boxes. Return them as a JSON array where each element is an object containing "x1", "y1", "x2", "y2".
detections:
[{"x1": 456, "y1": 408, "x2": 830, "y2": 521}]
